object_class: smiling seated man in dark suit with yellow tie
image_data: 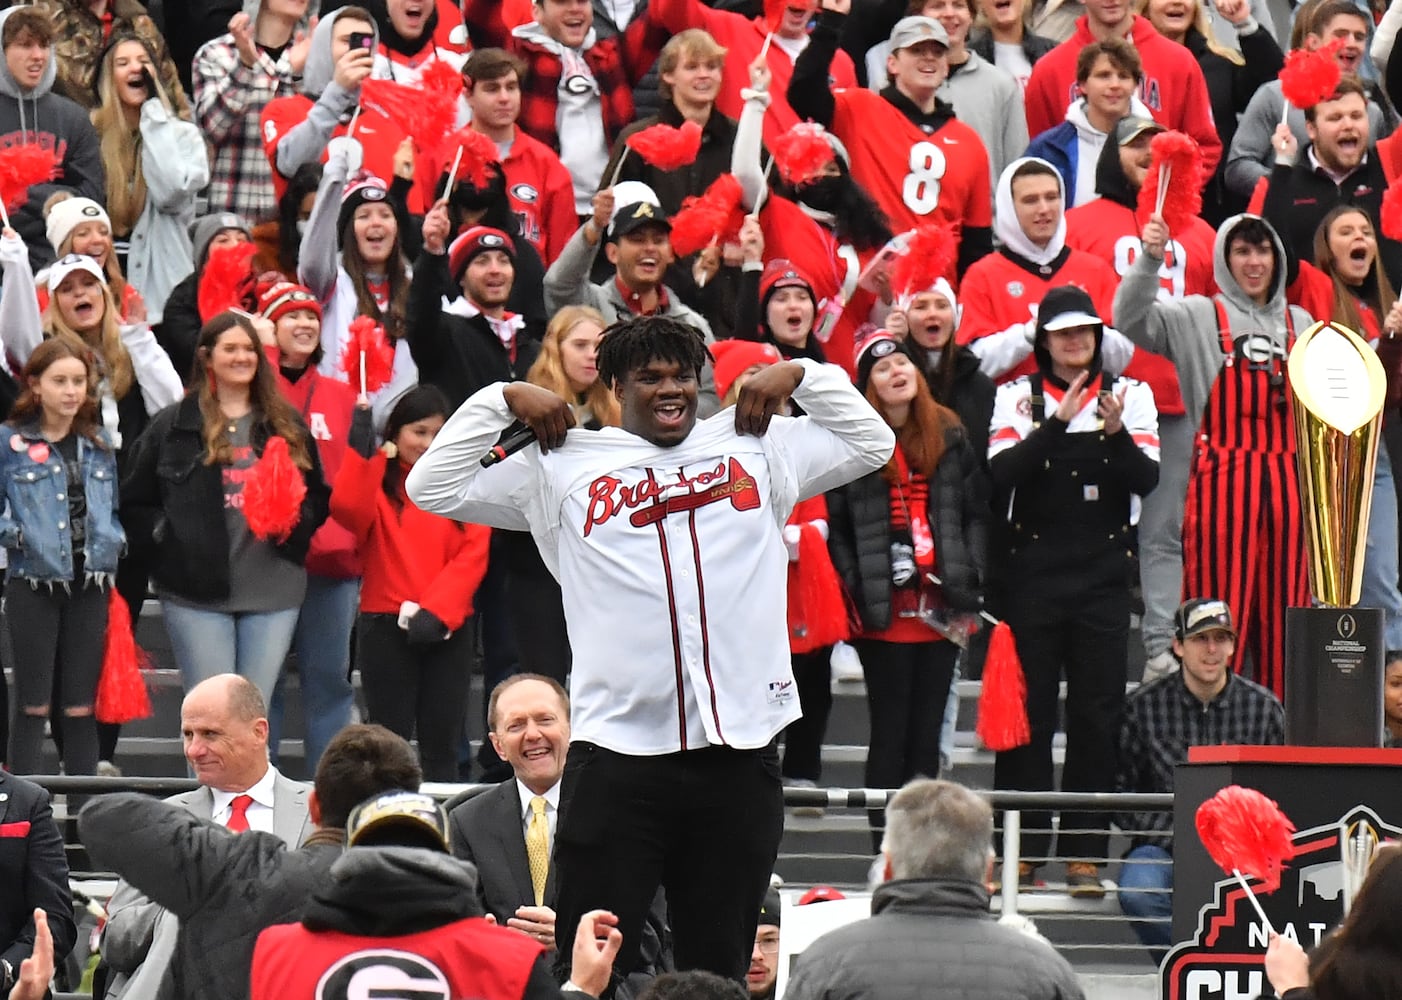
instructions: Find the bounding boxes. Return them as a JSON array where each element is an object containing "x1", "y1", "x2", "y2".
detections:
[{"x1": 449, "y1": 673, "x2": 569, "y2": 948}]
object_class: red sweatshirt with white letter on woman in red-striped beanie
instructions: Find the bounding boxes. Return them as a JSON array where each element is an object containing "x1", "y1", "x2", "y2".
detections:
[{"x1": 264, "y1": 345, "x2": 360, "y2": 579}]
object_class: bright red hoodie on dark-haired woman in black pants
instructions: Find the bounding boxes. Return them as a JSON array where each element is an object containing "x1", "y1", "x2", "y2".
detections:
[{"x1": 331, "y1": 449, "x2": 492, "y2": 631}]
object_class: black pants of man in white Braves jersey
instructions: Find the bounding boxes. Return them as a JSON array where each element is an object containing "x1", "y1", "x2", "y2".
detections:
[{"x1": 554, "y1": 742, "x2": 784, "y2": 983}]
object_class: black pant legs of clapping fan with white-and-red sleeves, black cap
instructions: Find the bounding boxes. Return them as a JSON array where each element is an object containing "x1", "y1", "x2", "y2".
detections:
[{"x1": 993, "y1": 592, "x2": 1130, "y2": 864}]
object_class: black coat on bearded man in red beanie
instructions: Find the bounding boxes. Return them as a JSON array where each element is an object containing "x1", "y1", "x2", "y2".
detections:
[{"x1": 405, "y1": 251, "x2": 540, "y2": 410}]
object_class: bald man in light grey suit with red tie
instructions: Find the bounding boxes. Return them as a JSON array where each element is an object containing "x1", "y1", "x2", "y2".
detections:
[{"x1": 101, "y1": 673, "x2": 313, "y2": 1000}]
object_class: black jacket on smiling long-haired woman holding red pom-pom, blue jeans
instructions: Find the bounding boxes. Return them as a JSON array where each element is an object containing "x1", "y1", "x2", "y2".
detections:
[{"x1": 122, "y1": 394, "x2": 331, "y2": 603}]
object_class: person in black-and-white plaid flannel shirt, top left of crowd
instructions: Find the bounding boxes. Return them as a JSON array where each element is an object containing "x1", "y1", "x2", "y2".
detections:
[{"x1": 193, "y1": 0, "x2": 310, "y2": 222}]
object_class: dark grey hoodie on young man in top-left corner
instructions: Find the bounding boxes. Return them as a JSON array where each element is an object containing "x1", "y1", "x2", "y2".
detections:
[{"x1": 0, "y1": 7, "x2": 107, "y2": 271}]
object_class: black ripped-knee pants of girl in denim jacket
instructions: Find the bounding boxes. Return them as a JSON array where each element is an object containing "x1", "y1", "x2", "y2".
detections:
[{"x1": 4, "y1": 579, "x2": 107, "y2": 774}]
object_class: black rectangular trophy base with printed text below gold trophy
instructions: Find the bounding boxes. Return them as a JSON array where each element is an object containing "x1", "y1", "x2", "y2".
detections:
[{"x1": 1286, "y1": 607, "x2": 1387, "y2": 746}]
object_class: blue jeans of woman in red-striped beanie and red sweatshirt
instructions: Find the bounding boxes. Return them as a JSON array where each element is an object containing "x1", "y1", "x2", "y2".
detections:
[{"x1": 268, "y1": 574, "x2": 360, "y2": 780}]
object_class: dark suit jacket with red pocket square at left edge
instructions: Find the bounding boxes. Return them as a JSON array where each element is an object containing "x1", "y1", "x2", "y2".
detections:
[{"x1": 0, "y1": 762, "x2": 79, "y2": 996}]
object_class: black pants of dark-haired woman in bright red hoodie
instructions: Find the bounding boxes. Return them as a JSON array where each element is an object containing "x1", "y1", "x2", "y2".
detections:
[{"x1": 356, "y1": 614, "x2": 472, "y2": 781}]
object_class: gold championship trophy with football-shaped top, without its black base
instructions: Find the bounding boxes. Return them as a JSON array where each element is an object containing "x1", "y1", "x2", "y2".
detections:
[{"x1": 1288, "y1": 323, "x2": 1387, "y2": 607}]
